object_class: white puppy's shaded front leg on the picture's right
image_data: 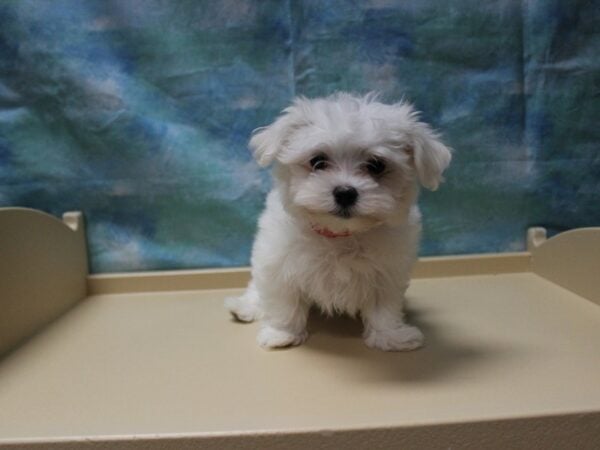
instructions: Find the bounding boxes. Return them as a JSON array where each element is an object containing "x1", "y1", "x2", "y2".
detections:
[{"x1": 361, "y1": 284, "x2": 424, "y2": 351}]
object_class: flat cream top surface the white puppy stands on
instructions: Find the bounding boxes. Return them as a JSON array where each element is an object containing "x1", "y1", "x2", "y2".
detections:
[{"x1": 0, "y1": 273, "x2": 600, "y2": 439}]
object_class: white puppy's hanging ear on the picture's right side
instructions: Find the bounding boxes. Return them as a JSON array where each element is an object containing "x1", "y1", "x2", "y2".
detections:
[{"x1": 407, "y1": 122, "x2": 452, "y2": 191}]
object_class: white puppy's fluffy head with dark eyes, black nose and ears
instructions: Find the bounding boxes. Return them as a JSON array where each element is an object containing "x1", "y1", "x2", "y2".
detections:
[{"x1": 250, "y1": 94, "x2": 450, "y2": 233}]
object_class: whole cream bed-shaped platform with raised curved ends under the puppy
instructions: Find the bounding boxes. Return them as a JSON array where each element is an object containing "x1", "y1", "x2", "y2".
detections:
[{"x1": 0, "y1": 208, "x2": 600, "y2": 450}]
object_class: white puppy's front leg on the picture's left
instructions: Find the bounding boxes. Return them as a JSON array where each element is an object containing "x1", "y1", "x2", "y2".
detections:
[{"x1": 257, "y1": 280, "x2": 309, "y2": 348}]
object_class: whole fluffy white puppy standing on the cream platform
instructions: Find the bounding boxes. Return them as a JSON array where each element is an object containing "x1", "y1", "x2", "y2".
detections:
[{"x1": 225, "y1": 93, "x2": 451, "y2": 351}]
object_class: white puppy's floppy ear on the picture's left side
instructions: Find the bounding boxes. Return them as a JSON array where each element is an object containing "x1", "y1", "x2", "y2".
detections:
[{"x1": 249, "y1": 98, "x2": 306, "y2": 167}]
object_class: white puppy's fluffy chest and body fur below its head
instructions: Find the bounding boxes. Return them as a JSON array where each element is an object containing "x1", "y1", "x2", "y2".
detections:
[{"x1": 252, "y1": 192, "x2": 419, "y2": 315}]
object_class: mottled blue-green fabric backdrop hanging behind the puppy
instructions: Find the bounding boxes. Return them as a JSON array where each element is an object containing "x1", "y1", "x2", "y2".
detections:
[{"x1": 0, "y1": 0, "x2": 600, "y2": 272}]
